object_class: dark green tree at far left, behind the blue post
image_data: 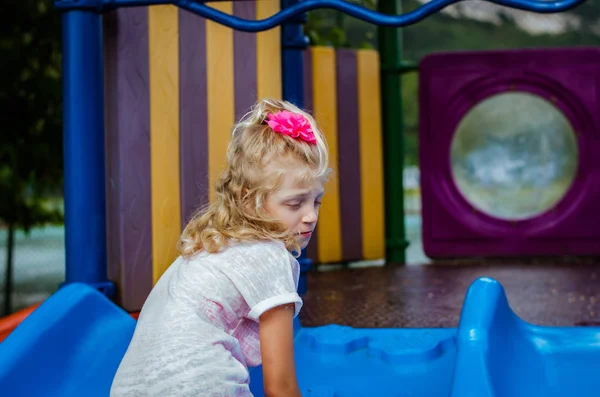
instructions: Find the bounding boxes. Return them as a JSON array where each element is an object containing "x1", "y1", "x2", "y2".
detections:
[{"x1": 0, "y1": 0, "x2": 63, "y2": 314}]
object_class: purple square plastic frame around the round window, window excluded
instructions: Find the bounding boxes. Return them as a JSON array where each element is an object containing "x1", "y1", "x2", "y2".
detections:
[{"x1": 419, "y1": 48, "x2": 600, "y2": 258}]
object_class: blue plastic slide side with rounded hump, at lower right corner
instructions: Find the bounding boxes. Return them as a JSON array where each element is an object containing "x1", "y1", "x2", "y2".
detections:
[{"x1": 452, "y1": 278, "x2": 600, "y2": 397}]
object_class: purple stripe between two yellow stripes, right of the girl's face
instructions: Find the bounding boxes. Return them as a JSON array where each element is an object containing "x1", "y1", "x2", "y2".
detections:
[{"x1": 336, "y1": 50, "x2": 363, "y2": 261}]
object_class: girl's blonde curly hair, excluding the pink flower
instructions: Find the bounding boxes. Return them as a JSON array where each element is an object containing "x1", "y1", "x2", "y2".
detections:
[{"x1": 178, "y1": 99, "x2": 331, "y2": 257}]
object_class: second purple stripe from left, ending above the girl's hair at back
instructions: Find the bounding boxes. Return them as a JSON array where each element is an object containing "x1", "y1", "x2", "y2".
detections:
[{"x1": 179, "y1": 10, "x2": 208, "y2": 227}]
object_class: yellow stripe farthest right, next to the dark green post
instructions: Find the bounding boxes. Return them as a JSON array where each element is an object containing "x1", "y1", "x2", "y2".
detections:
[{"x1": 356, "y1": 50, "x2": 385, "y2": 259}]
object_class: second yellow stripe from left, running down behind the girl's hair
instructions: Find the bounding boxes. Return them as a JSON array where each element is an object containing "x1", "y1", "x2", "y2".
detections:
[{"x1": 206, "y1": 1, "x2": 235, "y2": 202}]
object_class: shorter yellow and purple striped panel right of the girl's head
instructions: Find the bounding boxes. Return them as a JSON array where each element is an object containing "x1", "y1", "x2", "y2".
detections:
[{"x1": 304, "y1": 48, "x2": 385, "y2": 263}]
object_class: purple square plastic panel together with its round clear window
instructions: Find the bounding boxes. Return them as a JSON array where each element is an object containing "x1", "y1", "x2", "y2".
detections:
[{"x1": 419, "y1": 47, "x2": 600, "y2": 258}]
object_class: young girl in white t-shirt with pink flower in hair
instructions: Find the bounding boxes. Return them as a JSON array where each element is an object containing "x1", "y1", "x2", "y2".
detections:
[{"x1": 111, "y1": 100, "x2": 329, "y2": 397}]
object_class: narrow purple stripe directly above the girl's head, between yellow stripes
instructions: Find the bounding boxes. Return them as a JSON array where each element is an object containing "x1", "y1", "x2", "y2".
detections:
[{"x1": 233, "y1": 1, "x2": 257, "y2": 120}]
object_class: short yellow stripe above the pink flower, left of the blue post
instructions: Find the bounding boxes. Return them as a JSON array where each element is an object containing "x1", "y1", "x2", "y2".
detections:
[{"x1": 256, "y1": 0, "x2": 281, "y2": 99}]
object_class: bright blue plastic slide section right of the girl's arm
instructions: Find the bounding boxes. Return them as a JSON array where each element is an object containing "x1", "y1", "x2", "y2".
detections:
[{"x1": 251, "y1": 278, "x2": 600, "y2": 397}]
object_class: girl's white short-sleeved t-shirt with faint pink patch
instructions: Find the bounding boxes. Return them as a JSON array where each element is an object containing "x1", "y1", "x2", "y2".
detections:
[{"x1": 110, "y1": 241, "x2": 302, "y2": 397}]
